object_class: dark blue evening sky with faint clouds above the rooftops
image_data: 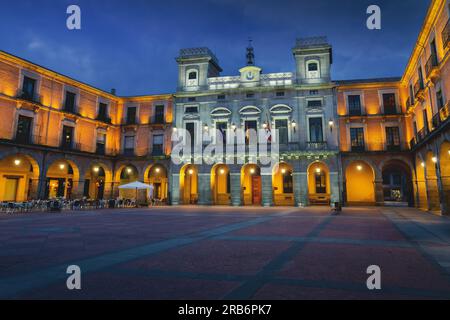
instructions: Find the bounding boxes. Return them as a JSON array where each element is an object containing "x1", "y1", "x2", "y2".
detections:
[{"x1": 0, "y1": 0, "x2": 430, "y2": 95}]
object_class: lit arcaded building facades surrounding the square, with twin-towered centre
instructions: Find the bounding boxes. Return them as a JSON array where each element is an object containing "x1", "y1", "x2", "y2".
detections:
[{"x1": 0, "y1": 0, "x2": 450, "y2": 214}]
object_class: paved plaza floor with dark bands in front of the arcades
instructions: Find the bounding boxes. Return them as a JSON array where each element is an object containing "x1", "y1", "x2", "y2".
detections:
[{"x1": 0, "y1": 207, "x2": 450, "y2": 300}]
